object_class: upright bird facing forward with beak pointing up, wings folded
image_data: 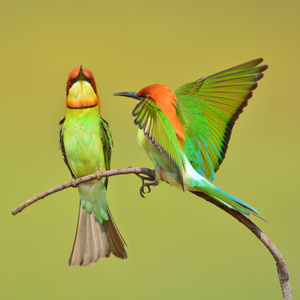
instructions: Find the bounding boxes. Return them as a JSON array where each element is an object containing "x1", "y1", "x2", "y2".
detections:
[{"x1": 60, "y1": 66, "x2": 127, "y2": 266}]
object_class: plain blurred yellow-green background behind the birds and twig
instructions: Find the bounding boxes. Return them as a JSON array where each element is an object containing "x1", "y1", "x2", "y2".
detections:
[{"x1": 0, "y1": 0, "x2": 300, "y2": 300}]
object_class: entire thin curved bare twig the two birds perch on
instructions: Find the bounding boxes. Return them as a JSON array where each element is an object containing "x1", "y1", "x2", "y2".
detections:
[{"x1": 11, "y1": 167, "x2": 293, "y2": 300}]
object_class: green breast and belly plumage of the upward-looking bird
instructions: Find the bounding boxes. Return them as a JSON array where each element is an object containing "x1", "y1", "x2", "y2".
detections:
[{"x1": 61, "y1": 106, "x2": 112, "y2": 223}]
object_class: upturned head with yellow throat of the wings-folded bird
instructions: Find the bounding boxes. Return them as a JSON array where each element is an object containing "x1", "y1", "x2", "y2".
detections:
[{"x1": 67, "y1": 66, "x2": 100, "y2": 108}]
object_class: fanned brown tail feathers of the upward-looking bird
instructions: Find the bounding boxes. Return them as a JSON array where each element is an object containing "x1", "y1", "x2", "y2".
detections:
[{"x1": 69, "y1": 205, "x2": 127, "y2": 266}]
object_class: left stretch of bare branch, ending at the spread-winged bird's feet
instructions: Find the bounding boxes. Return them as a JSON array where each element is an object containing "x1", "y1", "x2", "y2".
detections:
[{"x1": 11, "y1": 167, "x2": 155, "y2": 216}]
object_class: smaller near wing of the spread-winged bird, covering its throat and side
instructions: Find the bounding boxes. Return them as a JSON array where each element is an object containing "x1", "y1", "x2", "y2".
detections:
[{"x1": 132, "y1": 99, "x2": 184, "y2": 189}]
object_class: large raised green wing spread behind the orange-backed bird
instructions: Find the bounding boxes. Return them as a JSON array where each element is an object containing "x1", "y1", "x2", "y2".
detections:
[{"x1": 175, "y1": 58, "x2": 267, "y2": 181}]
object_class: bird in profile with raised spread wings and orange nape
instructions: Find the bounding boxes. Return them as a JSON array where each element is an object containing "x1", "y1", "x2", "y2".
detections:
[{"x1": 114, "y1": 58, "x2": 267, "y2": 217}]
